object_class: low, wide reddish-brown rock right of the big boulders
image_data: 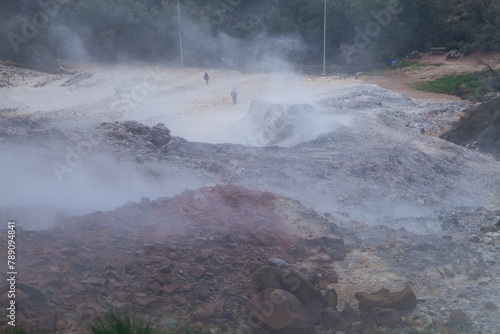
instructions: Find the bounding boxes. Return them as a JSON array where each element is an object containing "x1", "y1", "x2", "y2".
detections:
[{"x1": 354, "y1": 286, "x2": 417, "y2": 312}]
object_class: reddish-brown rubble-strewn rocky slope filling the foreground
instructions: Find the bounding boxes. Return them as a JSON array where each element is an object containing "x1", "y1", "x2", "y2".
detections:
[{"x1": 1, "y1": 186, "x2": 500, "y2": 333}]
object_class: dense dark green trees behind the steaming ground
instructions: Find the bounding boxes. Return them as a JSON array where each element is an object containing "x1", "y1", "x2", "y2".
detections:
[{"x1": 0, "y1": 0, "x2": 500, "y2": 71}]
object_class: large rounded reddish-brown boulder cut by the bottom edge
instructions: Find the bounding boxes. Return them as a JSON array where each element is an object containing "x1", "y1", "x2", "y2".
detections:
[{"x1": 246, "y1": 289, "x2": 316, "y2": 334}]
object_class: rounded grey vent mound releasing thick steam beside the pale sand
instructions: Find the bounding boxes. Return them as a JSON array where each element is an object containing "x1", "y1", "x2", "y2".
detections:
[{"x1": 247, "y1": 98, "x2": 314, "y2": 146}]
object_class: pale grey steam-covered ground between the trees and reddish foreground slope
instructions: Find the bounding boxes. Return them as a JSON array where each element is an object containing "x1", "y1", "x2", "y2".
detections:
[{"x1": 0, "y1": 60, "x2": 500, "y2": 235}]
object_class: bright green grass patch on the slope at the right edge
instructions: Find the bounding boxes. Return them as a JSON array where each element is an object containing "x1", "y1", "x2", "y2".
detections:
[{"x1": 412, "y1": 72, "x2": 498, "y2": 101}]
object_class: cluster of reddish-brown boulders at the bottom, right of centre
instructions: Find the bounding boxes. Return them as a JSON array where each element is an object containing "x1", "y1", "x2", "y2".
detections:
[{"x1": 246, "y1": 263, "x2": 417, "y2": 334}]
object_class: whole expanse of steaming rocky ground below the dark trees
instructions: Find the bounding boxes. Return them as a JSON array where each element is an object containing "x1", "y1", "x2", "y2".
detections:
[{"x1": 0, "y1": 61, "x2": 500, "y2": 334}]
